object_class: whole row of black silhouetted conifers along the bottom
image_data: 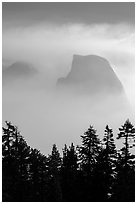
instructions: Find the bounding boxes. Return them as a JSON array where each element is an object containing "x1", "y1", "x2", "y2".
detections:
[{"x1": 2, "y1": 120, "x2": 135, "y2": 202}]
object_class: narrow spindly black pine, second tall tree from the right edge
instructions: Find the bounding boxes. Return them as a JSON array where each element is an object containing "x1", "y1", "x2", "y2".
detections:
[{"x1": 98, "y1": 125, "x2": 117, "y2": 201}]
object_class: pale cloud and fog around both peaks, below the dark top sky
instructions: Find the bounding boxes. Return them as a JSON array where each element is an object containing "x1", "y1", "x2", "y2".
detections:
[{"x1": 2, "y1": 24, "x2": 134, "y2": 152}]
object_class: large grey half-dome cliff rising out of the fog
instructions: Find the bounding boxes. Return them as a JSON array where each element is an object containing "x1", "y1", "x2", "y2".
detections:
[{"x1": 58, "y1": 55, "x2": 124, "y2": 94}]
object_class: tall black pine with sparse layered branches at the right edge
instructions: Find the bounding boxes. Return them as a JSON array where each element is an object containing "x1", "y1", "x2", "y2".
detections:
[{"x1": 113, "y1": 120, "x2": 135, "y2": 202}]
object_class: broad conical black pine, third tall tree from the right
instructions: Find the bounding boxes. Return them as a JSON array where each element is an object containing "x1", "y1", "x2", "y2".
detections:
[{"x1": 79, "y1": 126, "x2": 101, "y2": 202}]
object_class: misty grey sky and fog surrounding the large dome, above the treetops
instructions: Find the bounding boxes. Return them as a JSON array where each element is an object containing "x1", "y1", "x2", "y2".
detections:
[{"x1": 2, "y1": 2, "x2": 135, "y2": 153}]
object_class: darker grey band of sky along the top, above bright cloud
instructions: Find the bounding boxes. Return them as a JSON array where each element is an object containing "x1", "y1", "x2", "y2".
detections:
[{"x1": 3, "y1": 2, "x2": 135, "y2": 26}]
